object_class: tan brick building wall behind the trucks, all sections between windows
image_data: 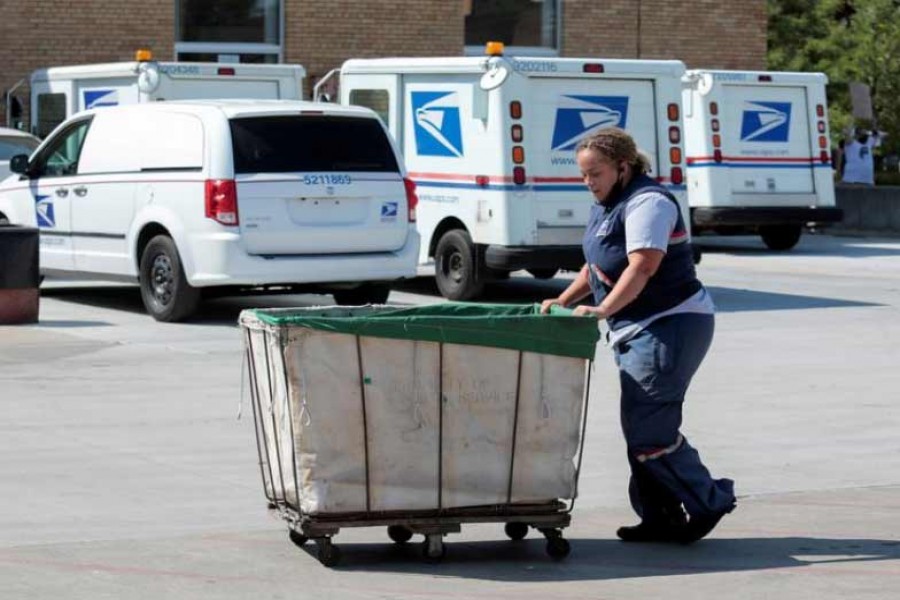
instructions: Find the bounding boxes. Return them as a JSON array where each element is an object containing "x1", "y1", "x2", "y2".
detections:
[{"x1": 0, "y1": 0, "x2": 766, "y2": 124}]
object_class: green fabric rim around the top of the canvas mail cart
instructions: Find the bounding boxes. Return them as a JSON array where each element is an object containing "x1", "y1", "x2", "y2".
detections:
[{"x1": 251, "y1": 302, "x2": 599, "y2": 358}]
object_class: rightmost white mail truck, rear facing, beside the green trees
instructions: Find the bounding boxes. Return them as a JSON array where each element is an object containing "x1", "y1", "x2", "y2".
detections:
[{"x1": 683, "y1": 70, "x2": 842, "y2": 250}]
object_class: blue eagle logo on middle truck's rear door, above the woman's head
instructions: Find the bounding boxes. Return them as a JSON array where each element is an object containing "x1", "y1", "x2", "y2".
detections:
[{"x1": 550, "y1": 96, "x2": 628, "y2": 152}]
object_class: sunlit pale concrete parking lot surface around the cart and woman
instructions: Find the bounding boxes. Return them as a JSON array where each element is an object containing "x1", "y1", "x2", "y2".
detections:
[{"x1": 0, "y1": 235, "x2": 900, "y2": 600}]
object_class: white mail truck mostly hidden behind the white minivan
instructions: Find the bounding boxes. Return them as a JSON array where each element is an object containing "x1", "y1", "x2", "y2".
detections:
[{"x1": 30, "y1": 50, "x2": 306, "y2": 138}]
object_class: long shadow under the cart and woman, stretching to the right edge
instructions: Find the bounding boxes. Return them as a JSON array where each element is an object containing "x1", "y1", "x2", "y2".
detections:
[{"x1": 303, "y1": 537, "x2": 900, "y2": 583}]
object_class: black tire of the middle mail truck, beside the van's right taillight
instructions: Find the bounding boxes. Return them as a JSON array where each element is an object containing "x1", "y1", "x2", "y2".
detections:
[{"x1": 434, "y1": 229, "x2": 484, "y2": 300}]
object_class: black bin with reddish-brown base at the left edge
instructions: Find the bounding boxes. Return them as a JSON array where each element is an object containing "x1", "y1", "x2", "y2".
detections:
[{"x1": 0, "y1": 225, "x2": 41, "y2": 325}]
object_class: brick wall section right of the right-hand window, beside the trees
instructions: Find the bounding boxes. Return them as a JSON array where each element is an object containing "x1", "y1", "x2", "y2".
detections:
[{"x1": 562, "y1": 0, "x2": 767, "y2": 70}]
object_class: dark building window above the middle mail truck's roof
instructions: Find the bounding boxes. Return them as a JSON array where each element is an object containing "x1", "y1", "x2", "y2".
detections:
[{"x1": 463, "y1": 0, "x2": 561, "y2": 56}]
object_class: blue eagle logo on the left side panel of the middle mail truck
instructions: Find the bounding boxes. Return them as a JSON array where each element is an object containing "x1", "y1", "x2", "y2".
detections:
[{"x1": 412, "y1": 92, "x2": 463, "y2": 158}]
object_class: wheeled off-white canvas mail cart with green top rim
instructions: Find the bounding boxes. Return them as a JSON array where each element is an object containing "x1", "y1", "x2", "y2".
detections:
[{"x1": 240, "y1": 303, "x2": 598, "y2": 566}]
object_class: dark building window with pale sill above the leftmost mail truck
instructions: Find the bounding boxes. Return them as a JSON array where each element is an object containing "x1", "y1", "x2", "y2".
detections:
[{"x1": 175, "y1": 0, "x2": 284, "y2": 63}]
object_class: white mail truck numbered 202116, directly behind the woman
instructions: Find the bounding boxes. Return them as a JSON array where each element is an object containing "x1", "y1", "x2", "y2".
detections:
[{"x1": 324, "y1": 47, "x2": 687, "y2": 300}]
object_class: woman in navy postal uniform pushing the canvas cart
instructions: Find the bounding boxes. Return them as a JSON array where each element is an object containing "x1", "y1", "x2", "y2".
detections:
[{"x1": 541, "y1": 128, "x2": 735, "y2": 544}]
